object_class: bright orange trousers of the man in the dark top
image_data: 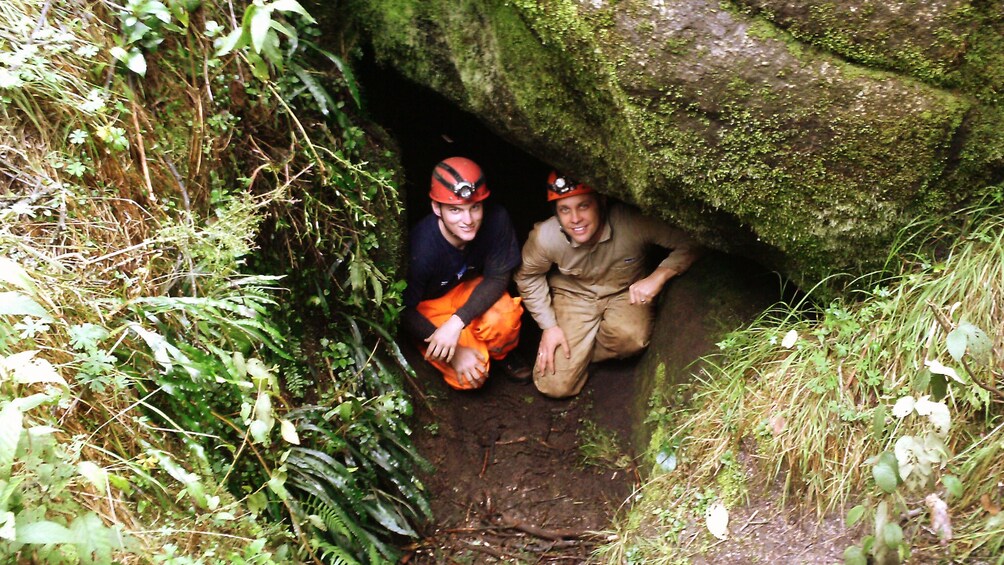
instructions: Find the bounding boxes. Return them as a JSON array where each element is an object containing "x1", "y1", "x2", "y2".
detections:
[{"x1": 416, "y1": 277, "x2": 523, "y2": 390}]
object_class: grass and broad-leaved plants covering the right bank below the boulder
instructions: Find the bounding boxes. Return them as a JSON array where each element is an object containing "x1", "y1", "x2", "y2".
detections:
[{"x1": 601, "y1": 192, "x2": 1004, "y2": 565}]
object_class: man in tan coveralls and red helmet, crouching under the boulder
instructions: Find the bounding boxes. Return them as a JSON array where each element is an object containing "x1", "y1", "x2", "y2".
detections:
[{"x1": 515, "y1": 172, "x2": 701, "y2": 398}]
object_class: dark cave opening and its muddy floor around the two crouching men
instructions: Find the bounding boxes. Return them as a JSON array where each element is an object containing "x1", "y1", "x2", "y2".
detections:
[{"x1": 359, "y1": 60, "x2": 781, "y2": 563}]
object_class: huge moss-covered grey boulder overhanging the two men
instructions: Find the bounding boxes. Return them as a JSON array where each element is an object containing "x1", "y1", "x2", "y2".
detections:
[{"x1": 338, "y1": 0, "x2": 1004, "y2": 291}]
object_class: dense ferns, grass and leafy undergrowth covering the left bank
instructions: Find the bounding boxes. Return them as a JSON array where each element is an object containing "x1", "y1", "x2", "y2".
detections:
[{"x1": 0, "y1": 0, "x2": 430, "y2": 564}]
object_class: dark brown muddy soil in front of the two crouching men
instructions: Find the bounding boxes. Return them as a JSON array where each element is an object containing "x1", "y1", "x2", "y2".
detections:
[{"x1": 397, "y1": 333, "x2": 638, "y2": 564}]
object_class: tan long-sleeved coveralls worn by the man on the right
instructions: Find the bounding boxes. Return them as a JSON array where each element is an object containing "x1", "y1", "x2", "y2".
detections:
[{"x1": 515, "y1": 204, "x2": 700, "y2": 397}]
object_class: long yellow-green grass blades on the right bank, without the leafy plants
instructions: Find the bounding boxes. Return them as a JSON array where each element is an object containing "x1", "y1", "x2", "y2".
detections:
[{"x1": 607, "y1": 193, "x2": 1004, "y2": 558}]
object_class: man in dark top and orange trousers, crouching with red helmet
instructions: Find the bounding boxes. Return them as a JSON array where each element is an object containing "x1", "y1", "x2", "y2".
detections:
[{"x1": 402, "y1": 157, "x2": 530, "y2": 389}]
